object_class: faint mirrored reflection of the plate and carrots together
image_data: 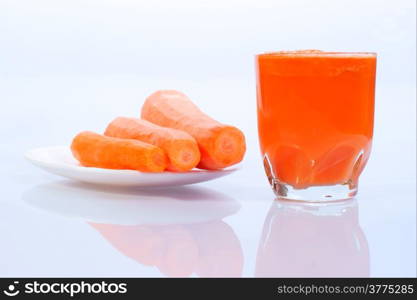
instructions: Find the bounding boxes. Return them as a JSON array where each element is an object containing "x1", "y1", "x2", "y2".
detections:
[{"x1": 23, "y1": 182, "x2": 243, "y2": 277}]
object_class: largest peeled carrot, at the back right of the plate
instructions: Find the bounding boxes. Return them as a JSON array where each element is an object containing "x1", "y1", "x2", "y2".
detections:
[{"x1": 142, "y1": 90, "x2": 246, "y2": 169}]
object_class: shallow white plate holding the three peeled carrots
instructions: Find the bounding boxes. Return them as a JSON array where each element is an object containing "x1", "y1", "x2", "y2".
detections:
[{"x1": 25, "y1": 146, "x2": 237, "y2": 187}]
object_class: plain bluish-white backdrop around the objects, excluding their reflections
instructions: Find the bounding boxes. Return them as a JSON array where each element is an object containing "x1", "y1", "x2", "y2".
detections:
[{"x1": 0, "y1": 0, "x2": 416, "y2": 276}]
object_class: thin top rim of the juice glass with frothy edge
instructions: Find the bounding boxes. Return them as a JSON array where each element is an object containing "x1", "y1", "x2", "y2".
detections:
[{"x1": 255, "y1": 50, "x2": 377, "y2": 58}]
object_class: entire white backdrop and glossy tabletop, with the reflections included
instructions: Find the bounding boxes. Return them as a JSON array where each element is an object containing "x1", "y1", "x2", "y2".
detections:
[{"x1": 0, "y1": 0, "x2": 416, "y2": 277}]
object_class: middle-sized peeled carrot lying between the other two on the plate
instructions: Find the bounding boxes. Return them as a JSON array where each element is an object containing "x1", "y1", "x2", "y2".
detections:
[{"x1": 104, "y1": 117, "x2": 200, "y2": 171}]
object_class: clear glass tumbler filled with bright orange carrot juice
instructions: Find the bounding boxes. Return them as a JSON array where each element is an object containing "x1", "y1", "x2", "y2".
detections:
[{"x1": 256, "y1": 50, "x2": 376, "y2": 201}]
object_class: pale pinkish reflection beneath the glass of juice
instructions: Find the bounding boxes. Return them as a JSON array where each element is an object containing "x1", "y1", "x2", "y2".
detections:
[{"x1": 255, "y1": 200, "x2": 369, "y2": 277}]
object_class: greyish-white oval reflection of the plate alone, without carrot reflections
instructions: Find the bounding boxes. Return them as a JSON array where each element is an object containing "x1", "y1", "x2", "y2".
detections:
[{"x1": 23, "y1": 181, "x2": 240, "y2": 225}]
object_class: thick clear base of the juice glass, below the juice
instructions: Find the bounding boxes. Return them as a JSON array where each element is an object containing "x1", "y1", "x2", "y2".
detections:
[{"x1": 271, "y1": 179, "x2": 358, "y2": 202}]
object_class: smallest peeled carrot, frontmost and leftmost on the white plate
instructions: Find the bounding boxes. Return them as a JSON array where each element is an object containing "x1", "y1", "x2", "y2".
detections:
[{"x1": 71, "y1": 131, "x2": 167, "y2": 172}]
